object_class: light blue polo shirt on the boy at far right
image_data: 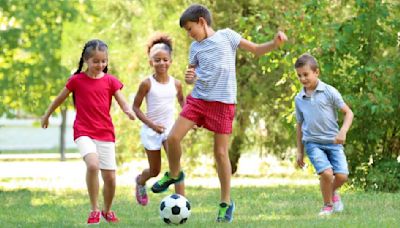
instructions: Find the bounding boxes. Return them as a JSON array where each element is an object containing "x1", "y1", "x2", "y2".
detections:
[{"x1": 295, "y1": 80, "x2": 345, "y2": 144}]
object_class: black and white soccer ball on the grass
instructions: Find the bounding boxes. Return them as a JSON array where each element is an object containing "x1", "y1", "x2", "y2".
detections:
[{"x1": 160, "y1": 194, "x2": 190, "y2": 224}]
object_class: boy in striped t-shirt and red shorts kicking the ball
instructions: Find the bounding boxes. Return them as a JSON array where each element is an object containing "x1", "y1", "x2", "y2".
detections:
[{"x1": 152, "y1": 4, "x2": 287, "y2": 222}]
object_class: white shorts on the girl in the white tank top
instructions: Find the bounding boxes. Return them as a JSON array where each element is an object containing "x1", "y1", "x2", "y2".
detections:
[{"x1": 140, "y1": 124, "x2": 171, "y2": 150}]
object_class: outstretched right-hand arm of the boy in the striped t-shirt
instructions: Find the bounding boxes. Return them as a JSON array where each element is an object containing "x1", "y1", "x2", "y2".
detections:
[{"x1": 239, "y1": 31, "x2": 287, "y2": 56}]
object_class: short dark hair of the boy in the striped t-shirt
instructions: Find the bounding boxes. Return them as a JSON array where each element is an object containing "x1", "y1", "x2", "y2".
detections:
[{"x1": 179, "y1": 4, "x2": 211, "y2": 28}]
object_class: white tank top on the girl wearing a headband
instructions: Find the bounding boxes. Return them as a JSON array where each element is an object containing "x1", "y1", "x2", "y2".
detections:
[{"x1": 146, "y1": 76, "x2": 177, "y2": 129}]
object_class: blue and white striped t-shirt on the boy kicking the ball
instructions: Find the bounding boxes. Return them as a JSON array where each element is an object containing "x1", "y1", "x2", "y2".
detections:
[{"x1": 189, "y1": 29, "x2": 242, "y2": 104}]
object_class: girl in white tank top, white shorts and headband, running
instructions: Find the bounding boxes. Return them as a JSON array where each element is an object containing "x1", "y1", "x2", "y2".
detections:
[{"x1": 133, "y1": 34, "x2": 185, "y2": 206}]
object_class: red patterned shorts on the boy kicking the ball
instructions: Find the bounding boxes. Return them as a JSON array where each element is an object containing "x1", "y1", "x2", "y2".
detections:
[{"x1": 180, "y1": 95, "x2": 235, "y2": 134}]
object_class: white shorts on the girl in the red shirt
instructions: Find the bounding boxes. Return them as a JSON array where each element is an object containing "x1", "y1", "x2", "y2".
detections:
[{"x1": 75, "y1": 136, "x2": 117, "y2": 170}]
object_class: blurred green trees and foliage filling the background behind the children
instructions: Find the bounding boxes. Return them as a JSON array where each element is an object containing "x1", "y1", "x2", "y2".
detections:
[{"x1": 0, "y1": 0, "x2": 400, "y2": 191}]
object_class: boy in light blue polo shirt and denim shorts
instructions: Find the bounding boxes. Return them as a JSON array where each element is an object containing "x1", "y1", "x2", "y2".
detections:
[{"x1": 294, "y1": 54, "x2": 353, "y2": 216}]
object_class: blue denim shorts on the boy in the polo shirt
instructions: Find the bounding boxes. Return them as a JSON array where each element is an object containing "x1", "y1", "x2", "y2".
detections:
[{"x1": 304, "y1": 142, "x2": 349, "y2": 175}]
